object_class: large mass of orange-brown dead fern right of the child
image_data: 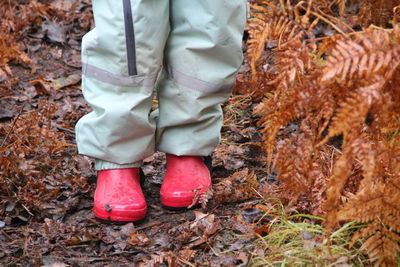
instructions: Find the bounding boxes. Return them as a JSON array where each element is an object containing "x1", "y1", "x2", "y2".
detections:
[{"x1": 248, "y1": 0, "x2": 400, "y2": 266}]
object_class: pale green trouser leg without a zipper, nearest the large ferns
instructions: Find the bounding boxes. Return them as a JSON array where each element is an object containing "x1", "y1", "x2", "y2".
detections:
[{"x1": 157, "y1": 0, "x2": 246, "y2": 156}]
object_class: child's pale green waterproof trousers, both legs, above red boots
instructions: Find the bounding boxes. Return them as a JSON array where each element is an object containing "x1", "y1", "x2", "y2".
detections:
[{"x1": 76, "y1": 0, "x2": 246, "y2": 170}]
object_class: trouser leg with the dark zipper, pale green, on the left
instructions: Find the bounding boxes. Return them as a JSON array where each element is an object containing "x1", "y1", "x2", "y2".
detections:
[{"x1": 76, "y1": 0, "x2": 169, "y2": 170}]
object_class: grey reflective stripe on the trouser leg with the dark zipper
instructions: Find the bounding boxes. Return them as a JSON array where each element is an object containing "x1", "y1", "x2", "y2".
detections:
[{"x1": 82, "y1": 64, "x2": 157, "y2": 87}]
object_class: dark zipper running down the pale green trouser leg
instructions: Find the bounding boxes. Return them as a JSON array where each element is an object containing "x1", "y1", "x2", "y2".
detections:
[{"x1": 123, "y1": 0, "x2": 137, "y2": 76}]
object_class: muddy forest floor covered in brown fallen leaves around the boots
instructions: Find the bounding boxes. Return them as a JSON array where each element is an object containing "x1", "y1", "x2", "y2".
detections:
[{"x1": 0, "y1": 1, "x2": 274, "y2": 266}]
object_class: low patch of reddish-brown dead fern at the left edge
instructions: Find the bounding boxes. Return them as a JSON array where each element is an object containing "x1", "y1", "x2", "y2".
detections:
[{"x1": 0, "y1": 101, "x2": 73, "y2": 215}]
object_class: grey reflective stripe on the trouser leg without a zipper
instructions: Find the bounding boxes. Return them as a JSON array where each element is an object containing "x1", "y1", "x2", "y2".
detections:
[{"x1": 167, "y1": 66, "x2": 232, "y2": 93}]
